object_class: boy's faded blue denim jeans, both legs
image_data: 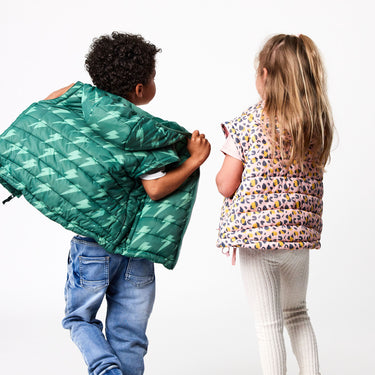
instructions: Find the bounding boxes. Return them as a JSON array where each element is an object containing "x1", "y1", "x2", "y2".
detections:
[{"x1": 63, "y1": 236, "x2": 155, "y2": 375}]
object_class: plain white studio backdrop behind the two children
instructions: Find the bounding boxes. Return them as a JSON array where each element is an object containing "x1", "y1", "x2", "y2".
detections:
[{"x1": 0, "y1": 0, "x2": 375, "y2": 375}]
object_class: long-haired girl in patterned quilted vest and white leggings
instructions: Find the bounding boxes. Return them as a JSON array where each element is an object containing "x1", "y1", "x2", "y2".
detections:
[{"x1": 216, "y1": 35, "x2": 333, "y2": 375}]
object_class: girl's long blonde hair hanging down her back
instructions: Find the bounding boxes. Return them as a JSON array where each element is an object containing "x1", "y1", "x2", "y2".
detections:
[{"x1": 257, "y1": 34, "x2": 334, "y2": 167}]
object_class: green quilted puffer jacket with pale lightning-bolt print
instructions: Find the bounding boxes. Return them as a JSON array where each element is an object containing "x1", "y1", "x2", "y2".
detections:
[{"x1": 0, "y1": 82, "x2": 199, "y2": 269}]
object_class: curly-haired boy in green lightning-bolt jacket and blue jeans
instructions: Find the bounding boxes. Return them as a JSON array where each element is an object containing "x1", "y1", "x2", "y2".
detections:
[{"x1": 0, "y1": 33, "x2": 210, "y2": 375}]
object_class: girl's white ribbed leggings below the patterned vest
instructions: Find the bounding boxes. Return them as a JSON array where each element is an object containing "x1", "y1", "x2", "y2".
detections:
[{"x1": 240, "y1": 248, "x2": 320, "y2": 375}]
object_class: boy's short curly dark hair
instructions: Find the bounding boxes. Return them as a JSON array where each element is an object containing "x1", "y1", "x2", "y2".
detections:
[{"x1": 85, "y1": 32, "x2": 161, "y2": 98}]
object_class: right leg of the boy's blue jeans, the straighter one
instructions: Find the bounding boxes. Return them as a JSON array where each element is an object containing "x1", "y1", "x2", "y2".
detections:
[{"x1": 106, "y1": 258, "x2": 155, "y2": 375}]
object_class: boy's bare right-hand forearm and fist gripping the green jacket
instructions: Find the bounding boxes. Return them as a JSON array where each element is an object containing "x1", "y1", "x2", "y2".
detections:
[{"x1": 142, "y1": 130, "x2": 211, "y2": 201}]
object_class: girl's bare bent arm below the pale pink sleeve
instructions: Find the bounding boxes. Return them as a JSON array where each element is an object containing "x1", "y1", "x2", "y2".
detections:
[{"x1": 216, "y1": 155, "x2": 243, "y2": 198}]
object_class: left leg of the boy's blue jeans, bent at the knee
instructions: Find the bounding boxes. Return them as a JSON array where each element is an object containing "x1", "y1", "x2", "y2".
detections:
[{"x1": 63, "y1": 237, "x2": 121, "y2": 375}]
